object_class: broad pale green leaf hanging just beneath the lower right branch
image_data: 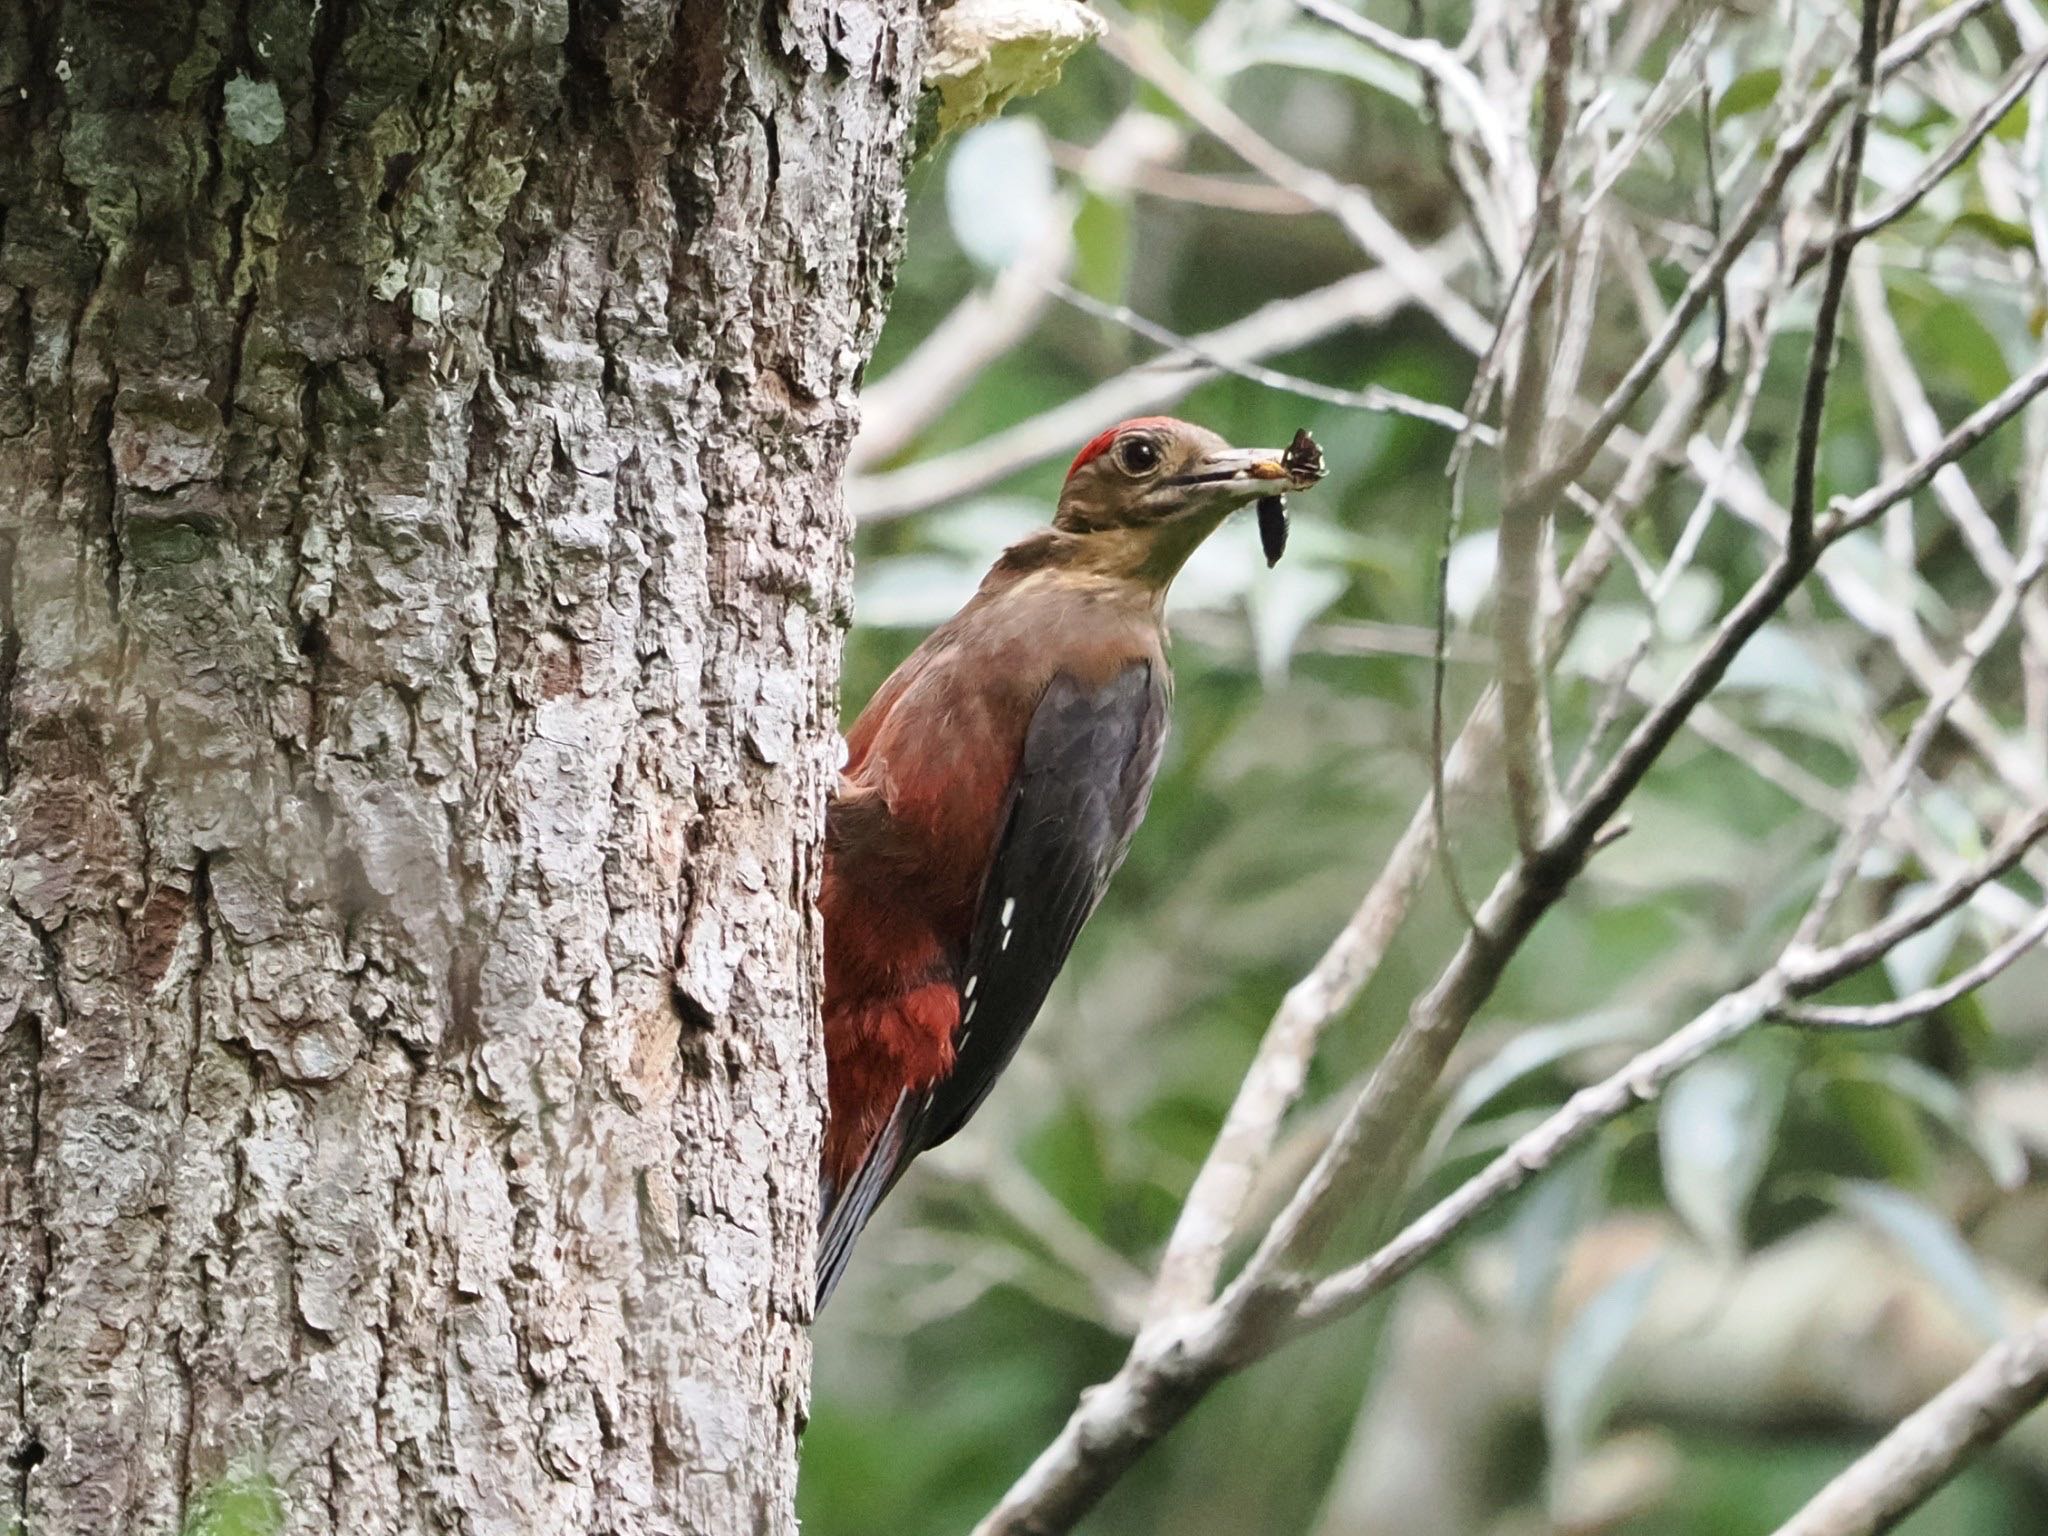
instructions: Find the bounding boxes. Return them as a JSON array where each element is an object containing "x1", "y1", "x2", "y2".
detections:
[{"x1": 1657, "y1": 1036, "x2": 1792, "y2": 1257}]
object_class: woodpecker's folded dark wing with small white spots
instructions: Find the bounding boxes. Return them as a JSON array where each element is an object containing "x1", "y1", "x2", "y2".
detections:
[{"x1": 909, "y1": 662, "x2": 1165, "y2": 1155}]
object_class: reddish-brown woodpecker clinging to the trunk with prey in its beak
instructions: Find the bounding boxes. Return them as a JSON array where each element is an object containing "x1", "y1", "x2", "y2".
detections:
[{"x1": 817, "y1": 416, "x2": 1323, "y2": 1307}]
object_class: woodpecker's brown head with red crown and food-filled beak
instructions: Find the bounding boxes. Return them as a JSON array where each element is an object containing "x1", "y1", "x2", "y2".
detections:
[{"x1": 1053, "y1": 416, "x2": 1323, "y2": 588}]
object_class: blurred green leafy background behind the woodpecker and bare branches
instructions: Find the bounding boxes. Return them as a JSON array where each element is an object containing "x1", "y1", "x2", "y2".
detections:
[{"x1": 803, "y1": 0, "x2": 2048, "y2": 1536}]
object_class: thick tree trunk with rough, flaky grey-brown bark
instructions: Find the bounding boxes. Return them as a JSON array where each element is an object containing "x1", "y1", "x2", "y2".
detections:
[{"x1": 0, "y1": 0, "x2": 922, "y2": 1536}]
